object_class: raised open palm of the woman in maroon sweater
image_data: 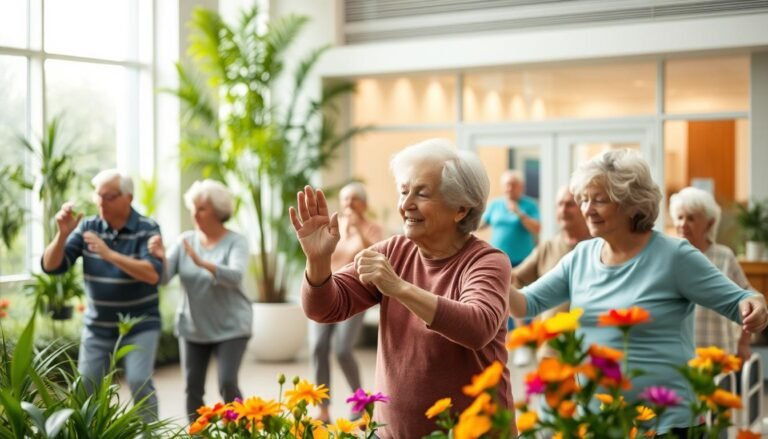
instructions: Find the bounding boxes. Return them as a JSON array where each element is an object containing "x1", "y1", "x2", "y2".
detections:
[{"x1": 288, "y1": 186, "x2": 339, "y2": 261}]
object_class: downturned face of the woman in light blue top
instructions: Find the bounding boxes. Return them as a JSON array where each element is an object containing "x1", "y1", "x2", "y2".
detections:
[{"x1": 579, "y1": 183, "x2": 632, "y2": 239}]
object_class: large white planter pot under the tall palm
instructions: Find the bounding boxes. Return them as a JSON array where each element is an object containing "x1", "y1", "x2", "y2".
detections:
[{"x1": 247, "y1": 303, "x2": 307, "y2": 362}]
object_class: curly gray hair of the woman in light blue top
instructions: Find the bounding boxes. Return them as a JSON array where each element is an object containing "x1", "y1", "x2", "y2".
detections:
[{"x1": 571, "y1": 149, "x2": 661, "y2": 233}]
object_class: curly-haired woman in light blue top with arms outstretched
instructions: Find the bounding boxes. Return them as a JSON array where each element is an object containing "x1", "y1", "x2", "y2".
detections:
[{"x1": 510, "y1": 151, "x2": 768, "y2": 437}]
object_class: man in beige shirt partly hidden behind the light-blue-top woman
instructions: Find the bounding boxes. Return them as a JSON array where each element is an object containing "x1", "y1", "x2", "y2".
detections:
[{"x1": 512, "y1": 186, "x2": 592, "y2": 358}]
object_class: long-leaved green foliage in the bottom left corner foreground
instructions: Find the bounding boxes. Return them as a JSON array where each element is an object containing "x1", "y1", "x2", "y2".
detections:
[{"x1": 0, "y1": 314, "x2": 179, "y2": 439}]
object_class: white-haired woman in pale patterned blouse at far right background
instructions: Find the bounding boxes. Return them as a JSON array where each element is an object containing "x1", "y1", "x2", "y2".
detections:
[{"x1": 669, "y1": 187, "x2": 752, "y2": 360}]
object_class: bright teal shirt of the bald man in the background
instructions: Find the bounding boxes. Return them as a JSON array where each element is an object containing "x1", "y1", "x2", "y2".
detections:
[{"x1": 483, "y1": 196, "x2": 540, "y2": 266}]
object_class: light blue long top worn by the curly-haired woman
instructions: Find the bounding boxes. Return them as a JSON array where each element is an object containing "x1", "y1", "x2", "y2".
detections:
[{"x1": 522, "y1": 231, "x2": 753, "y2": 434}]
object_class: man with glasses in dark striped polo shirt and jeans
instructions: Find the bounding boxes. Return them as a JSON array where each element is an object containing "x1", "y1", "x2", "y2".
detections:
[{"x1": 42, "y1": 170, "x2": 163, "y2": 422}]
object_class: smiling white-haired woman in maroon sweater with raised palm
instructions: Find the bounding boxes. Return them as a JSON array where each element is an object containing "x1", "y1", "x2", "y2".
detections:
[{"x1": 290, "y1": 139, "x2": 514, "y2": 438}]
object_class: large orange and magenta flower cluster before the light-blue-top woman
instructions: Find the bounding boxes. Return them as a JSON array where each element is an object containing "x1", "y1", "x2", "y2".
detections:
[{"x1": 426, "y1": 307, "x2": 757, "y2": 439}]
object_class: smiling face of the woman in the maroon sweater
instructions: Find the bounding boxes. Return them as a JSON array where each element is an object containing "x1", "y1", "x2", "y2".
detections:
[{"x1": 398, "y1": 162, "x2": 466, "y2": 250}]
